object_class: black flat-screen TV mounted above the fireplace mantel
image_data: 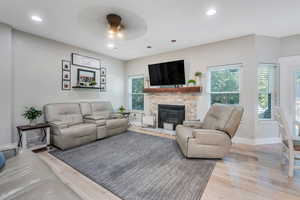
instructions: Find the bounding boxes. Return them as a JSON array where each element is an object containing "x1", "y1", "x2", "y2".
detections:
[{"x1": 148, "y1": 60, "x2": 185, "y2": 86}]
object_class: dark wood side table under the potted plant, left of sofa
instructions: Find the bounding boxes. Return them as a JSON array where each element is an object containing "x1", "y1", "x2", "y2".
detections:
[{"x1": 17, "y1": 123, "x2": 50, "y2": 150}]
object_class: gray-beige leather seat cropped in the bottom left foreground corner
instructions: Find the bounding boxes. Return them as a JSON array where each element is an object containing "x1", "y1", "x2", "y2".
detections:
[{"x1": 0, "y1": 148, "x2": 81, "y2": 200}]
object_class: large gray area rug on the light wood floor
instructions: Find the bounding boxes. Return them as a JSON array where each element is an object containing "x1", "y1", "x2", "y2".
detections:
[{"x1": 50, "y1": 132, "x2": 216, "y2": 200}]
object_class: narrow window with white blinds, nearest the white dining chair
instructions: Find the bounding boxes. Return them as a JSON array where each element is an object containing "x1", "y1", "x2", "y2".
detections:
[{"x1": 257, "y1": 64, "x2": 279, "y2": 119}]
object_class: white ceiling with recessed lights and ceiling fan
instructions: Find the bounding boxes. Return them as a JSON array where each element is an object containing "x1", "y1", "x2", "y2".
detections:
[{"x1": 0, "y1": 0, "x2": 300, "y2": 60}]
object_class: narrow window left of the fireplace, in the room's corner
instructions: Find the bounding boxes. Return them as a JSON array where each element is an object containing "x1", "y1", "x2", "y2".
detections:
[{"x1": 128, "y1": 76, "x2": 144, "y2": 110}]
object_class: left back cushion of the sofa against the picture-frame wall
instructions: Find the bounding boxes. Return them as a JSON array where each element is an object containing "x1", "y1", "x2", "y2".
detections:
[{"x1": 44, "y1": 103, "x2": 83, "y2": 125}]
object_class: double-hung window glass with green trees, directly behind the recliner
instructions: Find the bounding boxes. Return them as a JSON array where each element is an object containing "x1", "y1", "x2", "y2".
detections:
[{"x1": 208, "y1": 64, "x2": 241, "y2": 105}]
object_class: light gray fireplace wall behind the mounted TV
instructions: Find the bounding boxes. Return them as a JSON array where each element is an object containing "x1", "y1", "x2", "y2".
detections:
[{"x1": 125, "y1": 35, "x2": 256, "y2": 139}]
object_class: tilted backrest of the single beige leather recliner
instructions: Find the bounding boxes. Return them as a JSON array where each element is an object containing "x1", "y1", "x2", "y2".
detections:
[{"x1": 202, "y1": 104, "x2": 244, "y2": 138}]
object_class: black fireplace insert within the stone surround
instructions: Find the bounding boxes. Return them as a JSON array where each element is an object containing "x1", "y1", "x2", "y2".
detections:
[{"x1": 158, "y1": 104, "x2": 185, "y2": 130}]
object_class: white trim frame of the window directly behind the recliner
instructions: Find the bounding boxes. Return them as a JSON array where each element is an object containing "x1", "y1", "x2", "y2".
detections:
[{"x1": 206, "y1": 63, "x2": 243, "y2": 106}]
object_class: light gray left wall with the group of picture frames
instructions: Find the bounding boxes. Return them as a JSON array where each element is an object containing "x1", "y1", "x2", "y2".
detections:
[{"x1": 0, "y1": 26, "x2": 124, "y2": 143}]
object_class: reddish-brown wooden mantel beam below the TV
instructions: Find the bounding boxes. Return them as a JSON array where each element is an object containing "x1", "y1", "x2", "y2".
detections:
[{"x1": 144, "y1": 86, "x2": 202, "y2": 93}]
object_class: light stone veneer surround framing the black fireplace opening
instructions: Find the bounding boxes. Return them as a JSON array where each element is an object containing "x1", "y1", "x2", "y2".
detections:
[{"x1": 147, "y1": 93, "x2": 200, "y2": 120}]
